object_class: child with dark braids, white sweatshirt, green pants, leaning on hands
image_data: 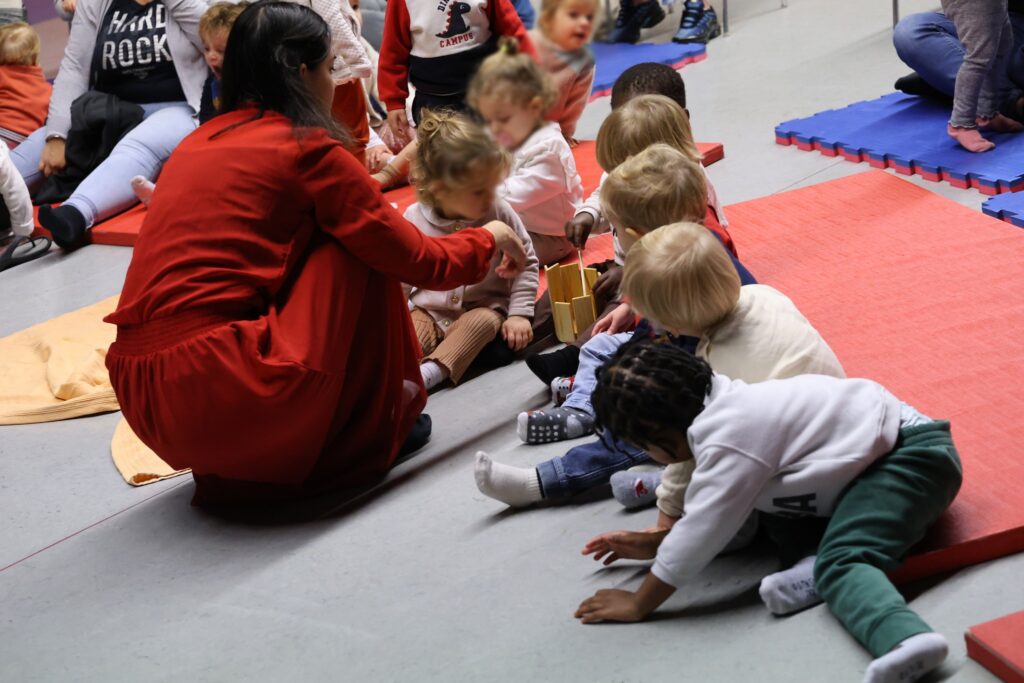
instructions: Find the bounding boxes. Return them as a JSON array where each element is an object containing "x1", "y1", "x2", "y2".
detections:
[{"x1": 575, "y1": 340, "x2": 963, "y2": 683}]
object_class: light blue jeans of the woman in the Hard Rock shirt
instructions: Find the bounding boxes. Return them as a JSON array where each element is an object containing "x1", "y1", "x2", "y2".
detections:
[{"x1": 10, "y1": 102, "x2": 196, "y2": 226}]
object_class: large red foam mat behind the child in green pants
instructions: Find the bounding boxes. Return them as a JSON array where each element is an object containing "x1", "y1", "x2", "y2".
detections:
[{"x1": 726, "y1": 171, "x2": 1024, "y2": 581}]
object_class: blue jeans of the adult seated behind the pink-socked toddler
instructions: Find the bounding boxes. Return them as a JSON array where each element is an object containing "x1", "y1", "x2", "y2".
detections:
[{"x1": 893, "y1": 12, "x2": 1024, "y2": 97}]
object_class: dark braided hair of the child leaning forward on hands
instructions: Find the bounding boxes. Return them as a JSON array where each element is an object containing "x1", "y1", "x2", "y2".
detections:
[{"x1": 591, "y1": 339, "x2": 712, "y2": 451}]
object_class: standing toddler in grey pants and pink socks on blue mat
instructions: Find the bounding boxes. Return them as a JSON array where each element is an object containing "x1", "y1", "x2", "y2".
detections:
[{"x1": 942, "y1": 0, "x2": 1024, "y2": 152}]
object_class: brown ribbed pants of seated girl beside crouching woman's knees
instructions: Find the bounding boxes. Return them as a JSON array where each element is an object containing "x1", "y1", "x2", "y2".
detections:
[{"x1": 413, "y1": 308, "x2": 505, "y2": 384}]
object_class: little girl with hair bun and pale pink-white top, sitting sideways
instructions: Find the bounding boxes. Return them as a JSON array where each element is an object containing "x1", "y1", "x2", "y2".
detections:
[{"x1": 467, "y1": 39, "x2": 583, "y2": 265}]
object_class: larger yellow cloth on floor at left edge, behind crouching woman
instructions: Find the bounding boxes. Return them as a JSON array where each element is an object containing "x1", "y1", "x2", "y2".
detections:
[{"x1": 0, "y1": 296, "x2": 120, "y2": 425}]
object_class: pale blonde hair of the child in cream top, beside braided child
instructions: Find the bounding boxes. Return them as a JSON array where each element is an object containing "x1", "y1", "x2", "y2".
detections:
[{"x1": 623, "y1": 222, "x2": 740, "y2": 335}]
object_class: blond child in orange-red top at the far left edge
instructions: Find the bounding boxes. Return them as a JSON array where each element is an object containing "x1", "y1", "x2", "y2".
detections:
[{"x1": 0, "y1": 22, "x2": 53, "y2": 148}]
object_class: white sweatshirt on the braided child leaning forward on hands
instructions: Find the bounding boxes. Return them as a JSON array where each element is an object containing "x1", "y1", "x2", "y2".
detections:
[{"x1": 651, "y1": 375, "x2": 900, "y2": 588}]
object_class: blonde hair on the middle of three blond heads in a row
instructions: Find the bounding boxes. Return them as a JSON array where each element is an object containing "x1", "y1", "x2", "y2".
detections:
[{"x1": 601, "y1": 143, "x2": 708, "y2": 234}]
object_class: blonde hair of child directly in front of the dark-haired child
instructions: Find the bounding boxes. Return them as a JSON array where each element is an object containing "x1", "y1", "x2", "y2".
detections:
[{"x1": 597, "y1": 95, "x2": 700, "y2": 173}]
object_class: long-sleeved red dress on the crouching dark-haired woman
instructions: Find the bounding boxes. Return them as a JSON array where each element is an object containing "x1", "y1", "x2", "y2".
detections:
[{"x1": 106, "y1": 110, "x2": 495, "y2": 504}]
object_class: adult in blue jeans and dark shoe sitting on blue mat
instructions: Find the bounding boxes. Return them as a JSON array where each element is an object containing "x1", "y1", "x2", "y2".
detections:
[{"x1": 893, "y1": 0, "x2": 1024, "y2": 120}]
